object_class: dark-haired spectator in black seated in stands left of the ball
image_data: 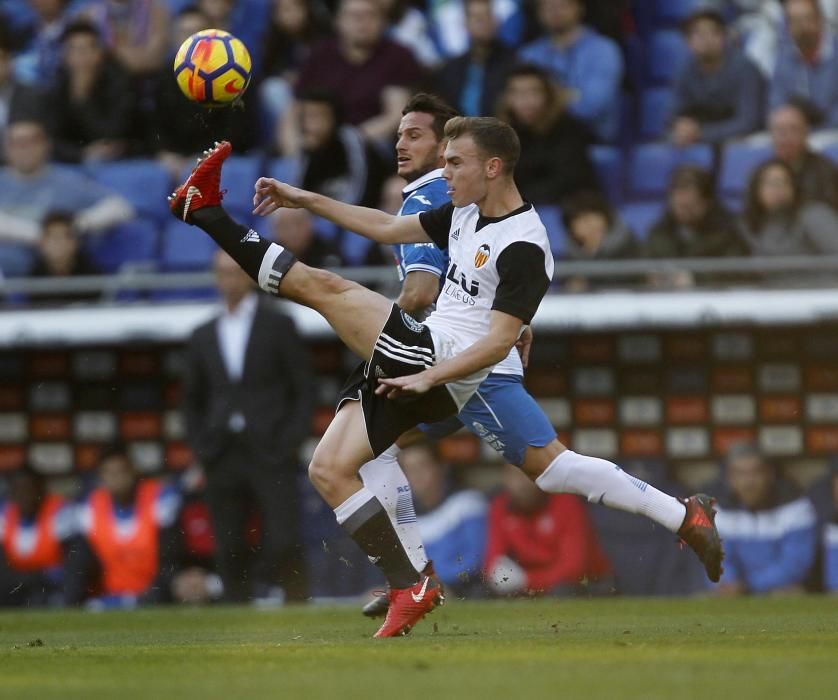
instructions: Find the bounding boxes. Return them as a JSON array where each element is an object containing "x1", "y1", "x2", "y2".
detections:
[{"x1": 49, "y1": 21, "x2": 138, "y2": 163}]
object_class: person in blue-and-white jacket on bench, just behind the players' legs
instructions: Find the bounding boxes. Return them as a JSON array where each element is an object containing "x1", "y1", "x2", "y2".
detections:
[{"x1": 397, "y1": 443, "x2": 488, "y2": 595}]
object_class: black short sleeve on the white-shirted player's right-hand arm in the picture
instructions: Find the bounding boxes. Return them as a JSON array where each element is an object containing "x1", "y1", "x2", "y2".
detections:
[{"x1": 492, "y1": 242, "x2": 550, "y2": 323}]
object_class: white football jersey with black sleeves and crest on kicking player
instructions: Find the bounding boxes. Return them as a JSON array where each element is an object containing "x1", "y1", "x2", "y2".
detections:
[{"x1": 419, "y1": 204, "x2": 553, "y2": 407}]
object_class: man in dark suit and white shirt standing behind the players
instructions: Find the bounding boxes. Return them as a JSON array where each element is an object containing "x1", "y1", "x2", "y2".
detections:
[{"x1": 183, "y1": 251, "x2": 314, "y2": 602}]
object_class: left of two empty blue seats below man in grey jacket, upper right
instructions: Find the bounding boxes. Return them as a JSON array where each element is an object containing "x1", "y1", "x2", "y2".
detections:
[{"x1": 629, "y1": 143, "x2": 713, "y2": 198}]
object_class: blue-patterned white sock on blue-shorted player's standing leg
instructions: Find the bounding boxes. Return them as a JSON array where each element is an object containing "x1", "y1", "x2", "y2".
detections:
[{"x1": 360, "y1": 445, "x2": 428, "y2": 573}]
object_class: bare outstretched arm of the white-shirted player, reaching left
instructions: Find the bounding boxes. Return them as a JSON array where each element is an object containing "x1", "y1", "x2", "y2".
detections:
[{"x1": 253, "y1": 177, "x2": 431, "y2": 244}]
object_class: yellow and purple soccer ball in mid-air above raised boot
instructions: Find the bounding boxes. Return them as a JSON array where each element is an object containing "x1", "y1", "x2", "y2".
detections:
[{"x1": 174, "y1": 29, "x2": 251, "y2": 107}]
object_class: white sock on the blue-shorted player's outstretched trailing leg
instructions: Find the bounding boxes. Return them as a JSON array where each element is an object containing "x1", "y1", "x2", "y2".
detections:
[{"x1": 535, "y1": 450, "x2": 687, "y2": 532}]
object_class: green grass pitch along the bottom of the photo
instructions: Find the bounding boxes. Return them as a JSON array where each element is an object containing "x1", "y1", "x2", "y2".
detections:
[{"x1": 0, "y1": 597, "x2": 838, "y2": 700}]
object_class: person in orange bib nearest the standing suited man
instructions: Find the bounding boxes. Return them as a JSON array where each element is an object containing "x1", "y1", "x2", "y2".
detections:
[{"x1": 65, "y1": 445, "x2": 182, "y2": 608}]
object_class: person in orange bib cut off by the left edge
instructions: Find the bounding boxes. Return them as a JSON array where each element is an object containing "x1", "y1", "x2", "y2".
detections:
[{"x1": 0, "y1": 468, "x2": 77, "y2": 607}]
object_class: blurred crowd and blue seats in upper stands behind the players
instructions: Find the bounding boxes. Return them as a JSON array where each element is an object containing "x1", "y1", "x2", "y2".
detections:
[{"x1": 0, "y1": 0, "x2": 838, "y2": 284}]
